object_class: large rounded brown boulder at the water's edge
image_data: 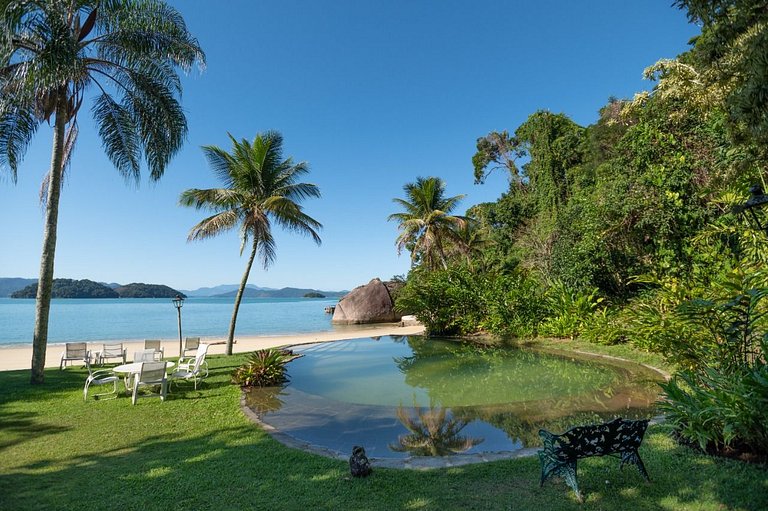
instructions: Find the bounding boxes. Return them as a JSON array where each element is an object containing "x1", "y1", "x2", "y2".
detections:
[{"x1": 331, "y1": 279, "x2": 400, "y2": 325}]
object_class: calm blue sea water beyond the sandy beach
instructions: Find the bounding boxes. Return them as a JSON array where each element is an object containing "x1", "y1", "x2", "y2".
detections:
[{"x1": 0, "y1": 298, "x2": 338, "y2": 346}]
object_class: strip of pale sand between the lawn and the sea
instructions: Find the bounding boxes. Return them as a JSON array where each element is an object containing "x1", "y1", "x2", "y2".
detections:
[{"x1": 0, "y1": 323, "x2": 424, "y2": 371}]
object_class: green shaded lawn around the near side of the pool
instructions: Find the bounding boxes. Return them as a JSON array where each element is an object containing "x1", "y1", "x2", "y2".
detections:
[{"x1": 0, "y1": 344, "x2": 768, "y2": 511}]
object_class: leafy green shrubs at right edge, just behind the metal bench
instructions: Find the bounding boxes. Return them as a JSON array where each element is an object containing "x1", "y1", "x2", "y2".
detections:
[{"x1": 660, "y1": 273, "x2": 768, "y2": 455}]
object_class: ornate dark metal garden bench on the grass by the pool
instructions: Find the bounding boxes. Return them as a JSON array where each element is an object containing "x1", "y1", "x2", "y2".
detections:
[{"x1": 539, "y1": 418, "x2": 650, "y2": 502}]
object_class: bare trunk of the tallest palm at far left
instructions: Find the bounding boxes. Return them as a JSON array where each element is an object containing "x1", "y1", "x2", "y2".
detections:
[{"x1": 30, "y1": 94, "x2": 67, "y2": 384}]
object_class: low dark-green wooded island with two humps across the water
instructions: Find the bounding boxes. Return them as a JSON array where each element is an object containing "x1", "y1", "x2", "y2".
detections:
[{"x1": 11, "y1": 279, "x2": 186, "y2": 298}]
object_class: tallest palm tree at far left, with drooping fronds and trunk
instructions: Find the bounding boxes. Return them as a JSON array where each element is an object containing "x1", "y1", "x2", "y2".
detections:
[{"x1": 0, "y1": 0, "x2": 205, "y2": 383}]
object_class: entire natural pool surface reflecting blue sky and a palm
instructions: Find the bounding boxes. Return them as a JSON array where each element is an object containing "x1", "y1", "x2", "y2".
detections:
[{"x1": 247, "y1": 337, "x2": 660, "y2": 457}]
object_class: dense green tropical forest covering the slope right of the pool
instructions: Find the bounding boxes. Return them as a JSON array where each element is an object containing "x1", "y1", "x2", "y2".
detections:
[{"x1": 390, "y1": 0, "x2": 768, "y2": 459}]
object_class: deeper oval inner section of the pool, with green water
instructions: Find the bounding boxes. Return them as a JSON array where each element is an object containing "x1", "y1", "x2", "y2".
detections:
[{"x1": 289, "y1": 337, "x2": 627, "y2": 406}]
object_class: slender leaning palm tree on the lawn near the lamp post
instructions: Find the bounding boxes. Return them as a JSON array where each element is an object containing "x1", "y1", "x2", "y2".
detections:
[{"x1": 179, "y1": 131, "x2": 322, "y2": 355}]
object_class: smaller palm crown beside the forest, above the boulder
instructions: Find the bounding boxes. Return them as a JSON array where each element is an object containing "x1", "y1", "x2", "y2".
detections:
[{"x1": 387, "y1": 177, "x2": 464, "y2": 269}]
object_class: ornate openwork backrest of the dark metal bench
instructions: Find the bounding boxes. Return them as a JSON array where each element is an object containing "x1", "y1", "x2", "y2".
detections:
[{"x1": 539, "y1": 418, "x2": 648, "y2": 460}]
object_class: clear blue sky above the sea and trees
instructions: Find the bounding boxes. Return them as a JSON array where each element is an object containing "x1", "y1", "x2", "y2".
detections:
[{"x1": 0, "y1": 0, "x2": 698, "y2": 290}]
